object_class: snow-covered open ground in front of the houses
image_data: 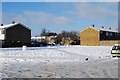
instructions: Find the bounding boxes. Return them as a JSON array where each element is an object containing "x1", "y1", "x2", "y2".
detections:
[{"x1": 0, "y1": 46, "x2": 118, "y2": 78}]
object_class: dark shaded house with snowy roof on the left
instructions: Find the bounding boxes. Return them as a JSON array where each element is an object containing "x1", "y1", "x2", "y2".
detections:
[{"x1": 0, "y1": 21, "x2": 31, "y2": 47}]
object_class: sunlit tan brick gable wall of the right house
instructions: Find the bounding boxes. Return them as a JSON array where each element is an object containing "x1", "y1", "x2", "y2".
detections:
[{"x1": 80, "y1": 27, "x2": 100, "y2": 46}]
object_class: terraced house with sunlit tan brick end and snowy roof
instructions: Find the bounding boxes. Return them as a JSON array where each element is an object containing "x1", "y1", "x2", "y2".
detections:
[{"x1": 80, "y1": 26, "x2": 120, "y2": 46}]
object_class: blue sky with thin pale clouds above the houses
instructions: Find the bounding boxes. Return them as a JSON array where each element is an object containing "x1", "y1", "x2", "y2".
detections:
[{"x1": 2, "y1": 0, "x2": 118, "y2": 35}]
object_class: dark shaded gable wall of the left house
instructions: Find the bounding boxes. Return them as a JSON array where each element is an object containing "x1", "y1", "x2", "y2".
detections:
[{"x1": 5, "y1": 24, "x2": 31, "y2": 45}]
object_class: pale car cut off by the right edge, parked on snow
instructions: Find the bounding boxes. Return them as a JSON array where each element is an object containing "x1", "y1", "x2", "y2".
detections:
[{"x1": 111, "y1": 44, "x2": 120, "y2": 57}]
